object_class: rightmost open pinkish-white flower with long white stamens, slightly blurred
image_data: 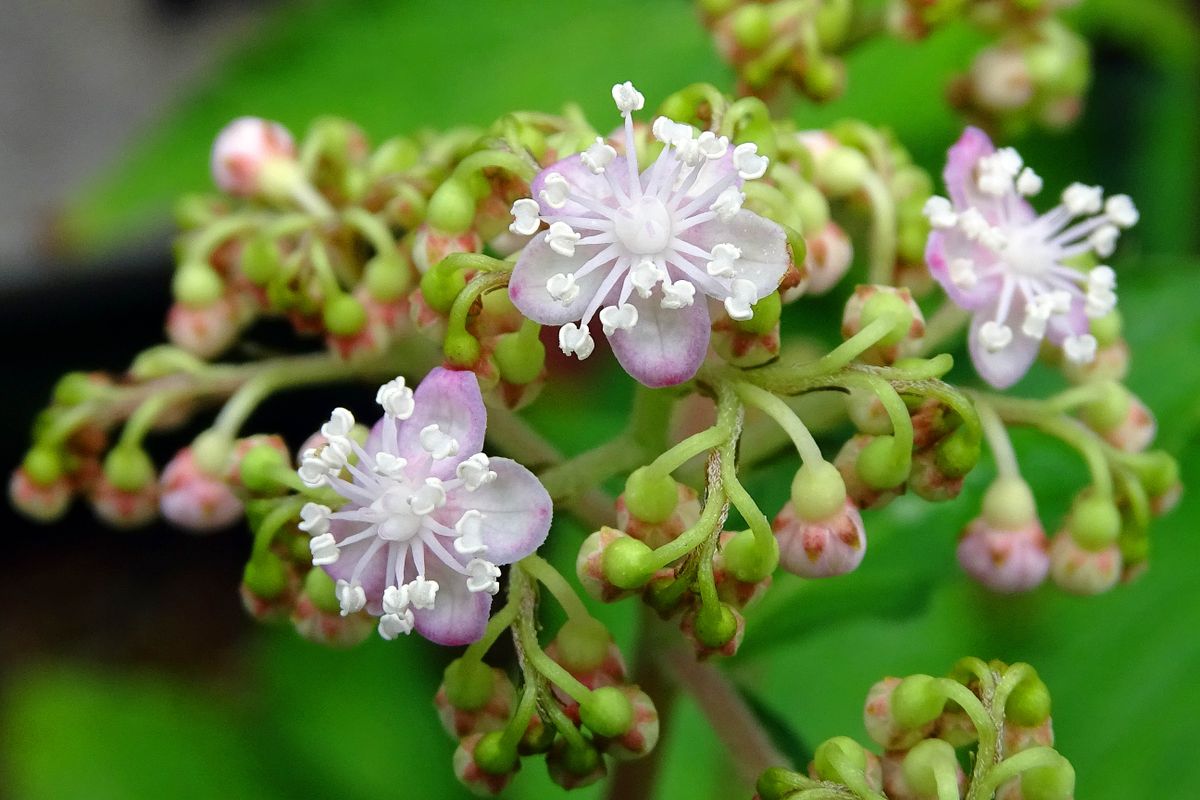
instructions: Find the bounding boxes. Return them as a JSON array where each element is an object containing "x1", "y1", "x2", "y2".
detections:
[{"x1": 925, "y1": 128, "x2": 1138, "y2": 389}]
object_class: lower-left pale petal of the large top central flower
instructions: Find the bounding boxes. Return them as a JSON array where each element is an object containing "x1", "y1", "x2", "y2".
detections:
[{"x1": 509, "y1": 233, "x2": 616, "y2": 325}]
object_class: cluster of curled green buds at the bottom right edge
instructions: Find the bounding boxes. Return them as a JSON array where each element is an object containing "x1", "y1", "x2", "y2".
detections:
[{"x1": 757, "y1": 658, "x2": 1075, "y2": 800}]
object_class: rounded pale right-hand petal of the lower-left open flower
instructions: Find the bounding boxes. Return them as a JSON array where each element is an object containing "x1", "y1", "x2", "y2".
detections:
[{"x1": 446, "y1": 458, "x2": 553, "y2": 564}]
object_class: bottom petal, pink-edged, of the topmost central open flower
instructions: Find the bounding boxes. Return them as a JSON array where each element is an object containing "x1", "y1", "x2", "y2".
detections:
[{"x1": 608, "y1": 291, "x2": 709, "y2": 389}]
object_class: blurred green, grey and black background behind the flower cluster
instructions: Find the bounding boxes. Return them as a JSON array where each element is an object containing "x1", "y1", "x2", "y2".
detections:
[{"x1": 0, "y1": 0, "x2": 1200, "y2": 800}]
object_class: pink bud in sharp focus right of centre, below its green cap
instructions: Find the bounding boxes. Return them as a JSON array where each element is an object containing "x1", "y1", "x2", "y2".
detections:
[{"x1": 773, "y1": 498, "x2": 866, "y2": 578}]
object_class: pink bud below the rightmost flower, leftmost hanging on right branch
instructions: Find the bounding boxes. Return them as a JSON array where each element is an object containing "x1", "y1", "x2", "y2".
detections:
[{"x1": 958, "y1": 518, "x2": 1050, "y2": 594}]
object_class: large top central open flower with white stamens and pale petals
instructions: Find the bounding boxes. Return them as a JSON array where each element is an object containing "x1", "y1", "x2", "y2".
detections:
[{"x1": 509, "y1": 82, "x2": 791, "y2": 386}]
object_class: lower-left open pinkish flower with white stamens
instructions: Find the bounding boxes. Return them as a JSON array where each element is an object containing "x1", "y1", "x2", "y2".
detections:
[{"x1": 299, "y1": 368, "x2": 551, "y2": 645}]
